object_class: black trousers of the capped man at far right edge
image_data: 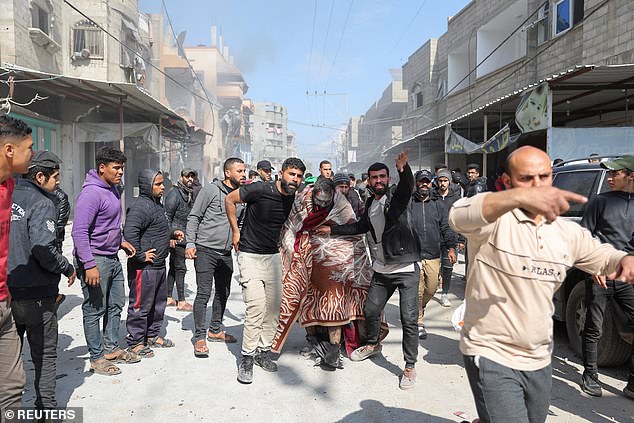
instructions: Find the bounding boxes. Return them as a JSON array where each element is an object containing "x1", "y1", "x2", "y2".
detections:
[{"x1": 582, "y1": 279, "x2": 634, "y2": 378}]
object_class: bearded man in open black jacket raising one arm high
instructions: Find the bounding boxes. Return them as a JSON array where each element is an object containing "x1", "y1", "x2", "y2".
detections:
[{"x1": 317, "y1": 152, "x2": 420, "y2": 389}]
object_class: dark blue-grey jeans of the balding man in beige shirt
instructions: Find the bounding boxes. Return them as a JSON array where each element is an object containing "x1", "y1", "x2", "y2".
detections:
[{"x1": 463, "y1": 355, "x2": 553, "y2": 423}]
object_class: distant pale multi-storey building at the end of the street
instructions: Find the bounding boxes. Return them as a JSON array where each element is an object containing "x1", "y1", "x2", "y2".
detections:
[{"x1": 249, "y1": 102, "x2": 297, "y2": 170}]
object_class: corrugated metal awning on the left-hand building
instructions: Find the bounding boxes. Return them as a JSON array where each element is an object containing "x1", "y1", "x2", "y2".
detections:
[{"x1": 0, "y1": 63, "x2": 188, "y2": 128}]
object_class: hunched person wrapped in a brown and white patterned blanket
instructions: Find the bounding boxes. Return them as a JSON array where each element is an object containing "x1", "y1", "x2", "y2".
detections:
[{"x1": 272, "y1": 178, "x2": 387, "y2": 369}]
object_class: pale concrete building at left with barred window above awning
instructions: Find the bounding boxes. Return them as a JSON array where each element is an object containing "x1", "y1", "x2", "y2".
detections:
[{"x1": 0, "y1": 0, "x2": 188, "y2": 210}]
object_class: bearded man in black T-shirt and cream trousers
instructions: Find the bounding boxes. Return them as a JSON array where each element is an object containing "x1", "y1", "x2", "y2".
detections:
[{"x1": 225, "y1": 157, "x2": 306, "y2": 383}]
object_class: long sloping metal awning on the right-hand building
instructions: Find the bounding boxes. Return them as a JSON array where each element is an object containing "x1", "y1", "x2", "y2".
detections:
[{"x1": 383, "y1": 64, "x2": 634, "y2": 154}]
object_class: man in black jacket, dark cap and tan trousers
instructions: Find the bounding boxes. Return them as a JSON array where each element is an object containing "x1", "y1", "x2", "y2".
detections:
[{"x1": 411, "y1": 170, "x2": 456, "y2": 339}]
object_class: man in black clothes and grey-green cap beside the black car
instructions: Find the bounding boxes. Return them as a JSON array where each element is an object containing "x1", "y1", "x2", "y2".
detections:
[{"x1": 581, "y1": 156, "x2": 634, "y2": 399}]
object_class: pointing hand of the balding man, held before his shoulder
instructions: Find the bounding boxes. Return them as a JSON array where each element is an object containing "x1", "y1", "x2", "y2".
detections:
[{"x1": 520, "y1": 187, "x2": 588, "y2": 222}]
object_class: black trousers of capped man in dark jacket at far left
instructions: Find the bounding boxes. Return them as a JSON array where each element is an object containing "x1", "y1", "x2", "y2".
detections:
[{"x1": 11, "y1": 297, "x2": 57, "y2": 409}]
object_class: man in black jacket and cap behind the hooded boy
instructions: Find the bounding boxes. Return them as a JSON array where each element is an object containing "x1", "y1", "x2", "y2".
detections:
[{"x1": 165, "y1": 168, "x2": 198, "y2": 311}]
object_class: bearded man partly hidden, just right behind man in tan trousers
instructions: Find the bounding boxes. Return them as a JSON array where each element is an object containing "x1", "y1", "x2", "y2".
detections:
[{"x1": 432, "y1": 169, "x2": 465, "y2": 307}]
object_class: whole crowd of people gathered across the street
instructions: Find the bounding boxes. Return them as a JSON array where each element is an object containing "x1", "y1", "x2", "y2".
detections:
[{"x1": 0, "y1": 116, "x2": 634, "y2": 422}]
